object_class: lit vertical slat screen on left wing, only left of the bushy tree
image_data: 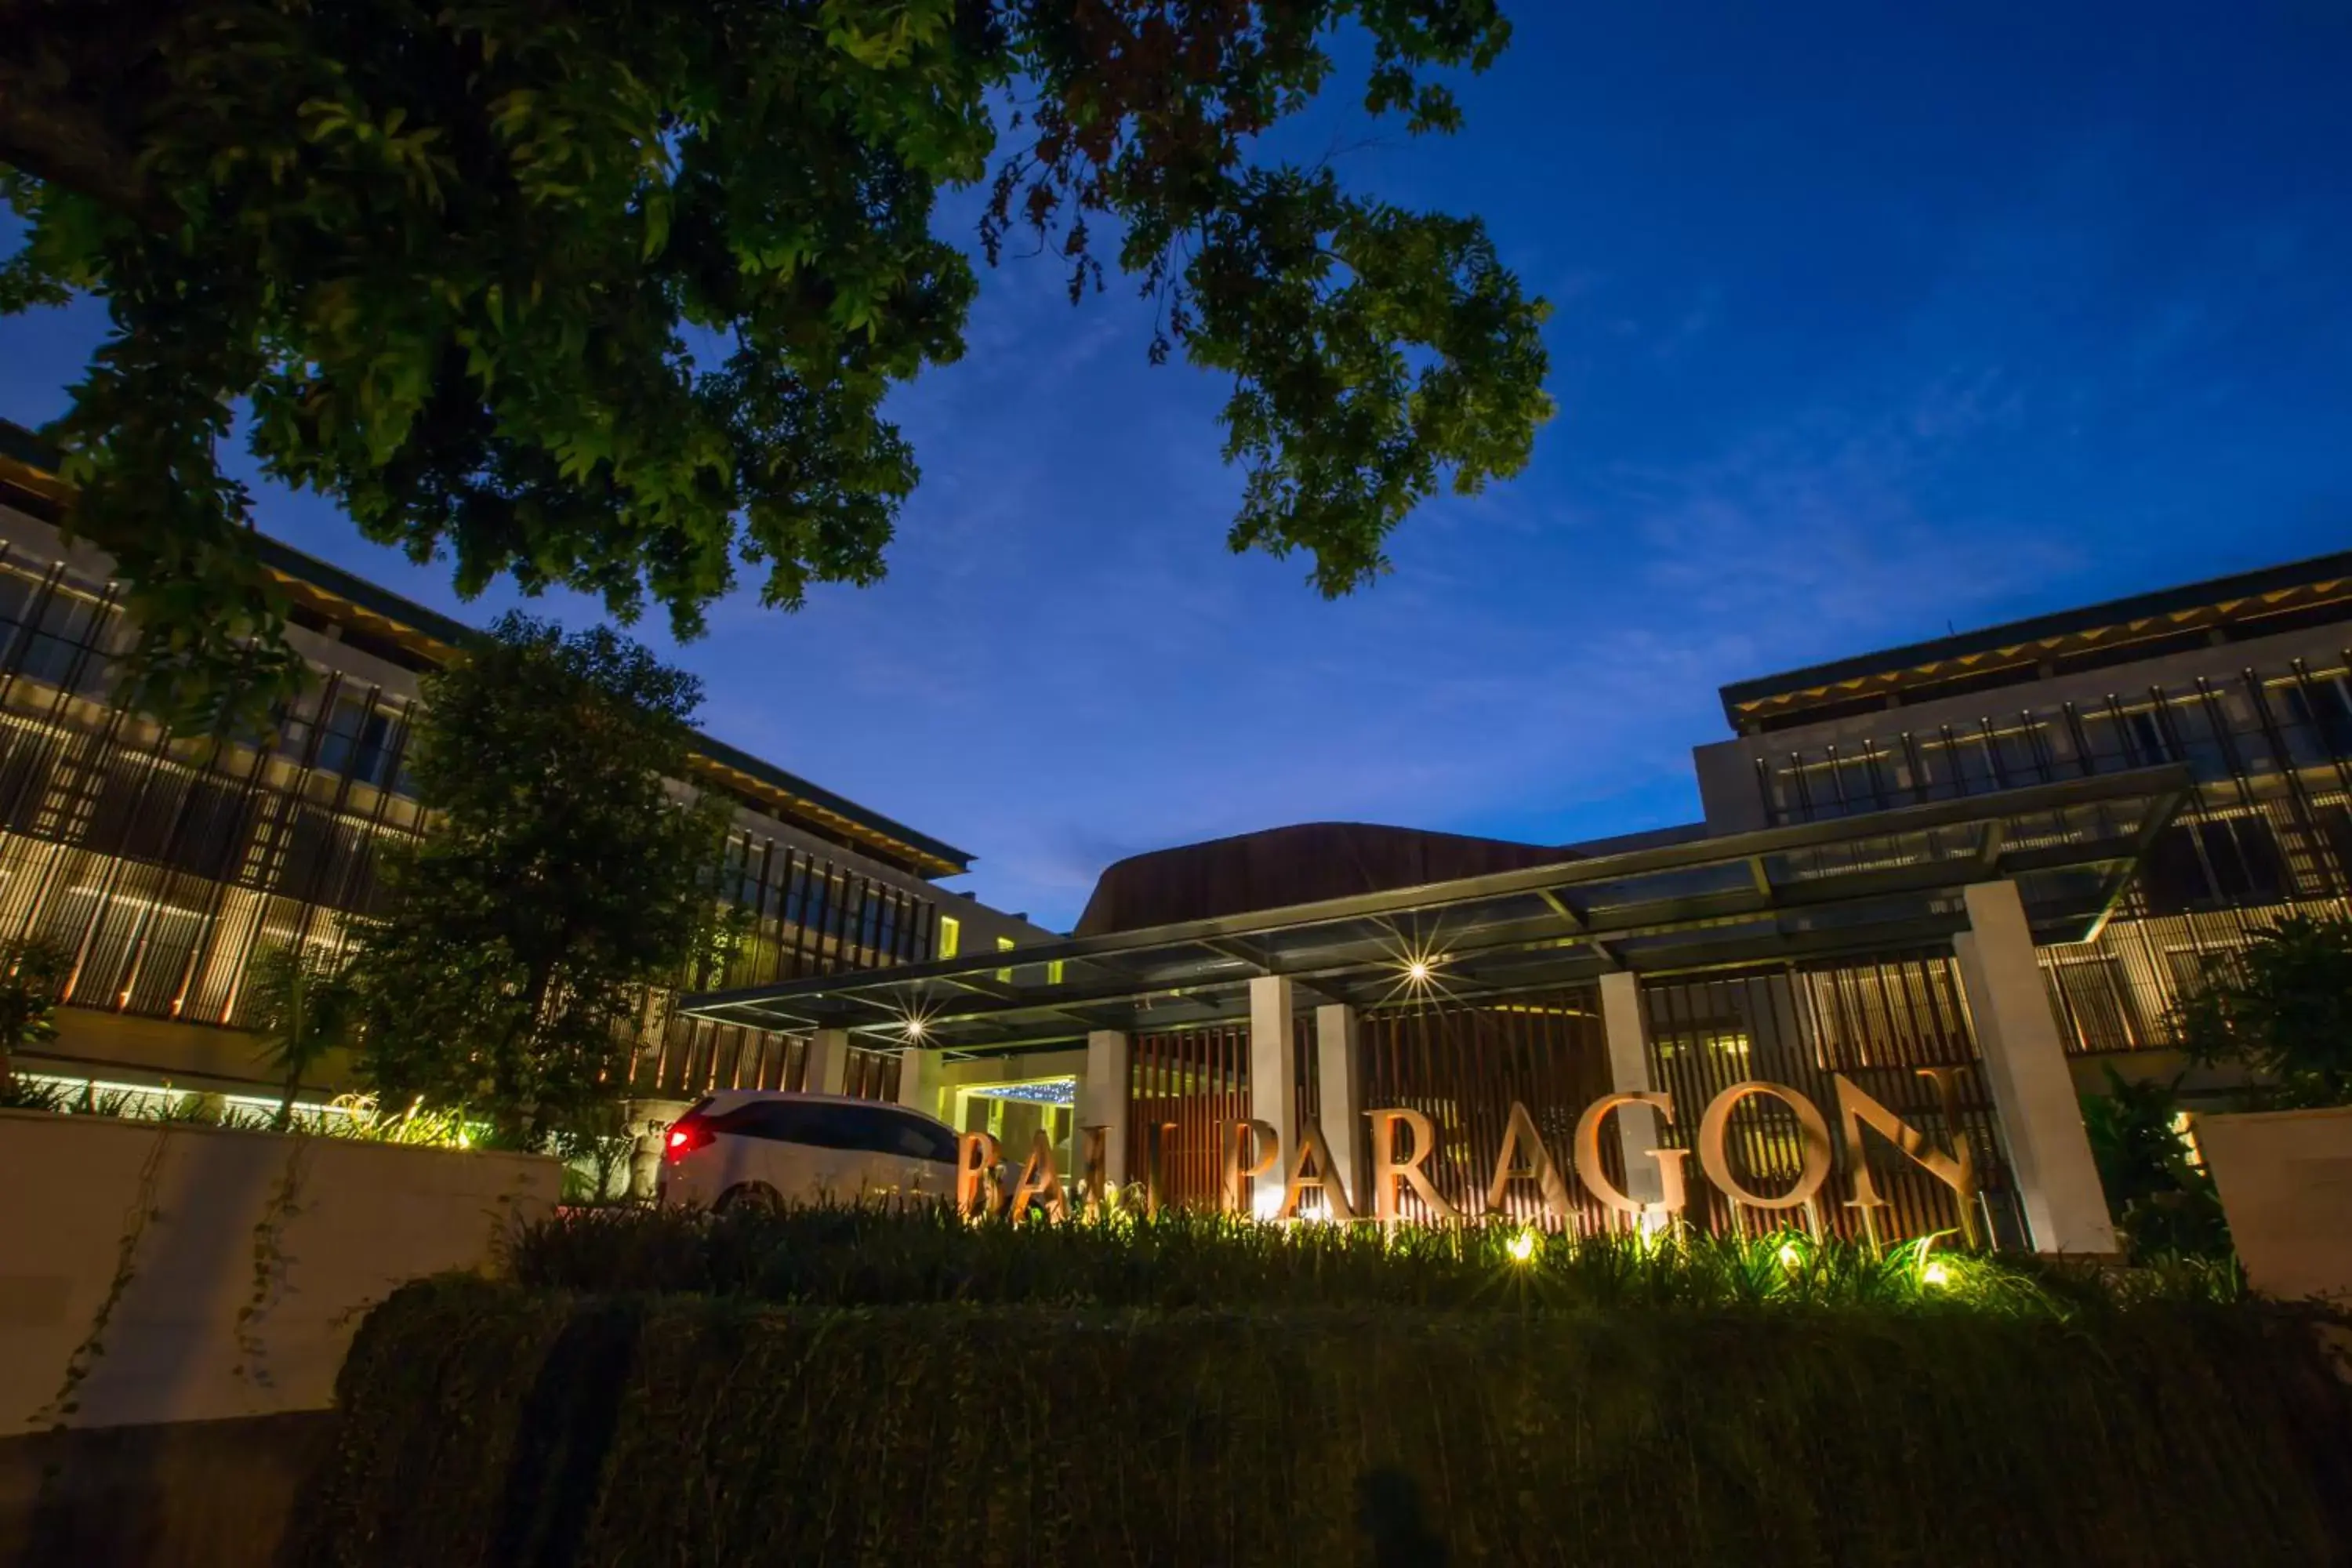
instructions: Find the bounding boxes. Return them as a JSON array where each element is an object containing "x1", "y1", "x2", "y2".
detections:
[{"x1": 0, "y1": 567, "x2": 421, "y2": 1025}]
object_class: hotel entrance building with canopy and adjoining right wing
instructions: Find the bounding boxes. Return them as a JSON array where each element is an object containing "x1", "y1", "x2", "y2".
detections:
[{"x1": 682, "y1": 555, "x2": 2352, "y2": 1253}]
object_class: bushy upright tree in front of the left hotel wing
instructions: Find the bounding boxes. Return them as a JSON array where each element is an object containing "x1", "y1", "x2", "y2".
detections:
[{"x1": 358, "y1": 614, "x2": 727, "y2": 1142}]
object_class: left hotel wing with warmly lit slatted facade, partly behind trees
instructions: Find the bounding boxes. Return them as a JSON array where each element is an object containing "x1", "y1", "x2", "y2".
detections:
[{"x1": 0, "y1": 423, "x2": 1051, "y2": 1114}]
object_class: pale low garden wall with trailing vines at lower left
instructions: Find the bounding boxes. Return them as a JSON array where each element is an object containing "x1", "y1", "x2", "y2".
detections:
[{"x1": 0, "y1": 1112, "x2": 562, "y2": 1439}]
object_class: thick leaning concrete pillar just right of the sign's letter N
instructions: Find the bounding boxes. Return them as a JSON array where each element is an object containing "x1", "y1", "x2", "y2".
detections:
[{"x1": 1952, "y1": 881, "x2": 2114, "y2": 1253}]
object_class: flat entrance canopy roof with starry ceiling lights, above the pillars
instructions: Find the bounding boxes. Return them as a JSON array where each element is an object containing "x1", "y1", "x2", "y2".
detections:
[{"x1": 682, "y1": 767, "x2": 2192, "y2": 1053}]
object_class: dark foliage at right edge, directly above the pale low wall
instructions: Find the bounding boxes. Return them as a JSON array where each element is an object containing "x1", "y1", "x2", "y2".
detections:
[{"x1": 2180, "y1": 914, "x2": 2352, "y2": 1109}]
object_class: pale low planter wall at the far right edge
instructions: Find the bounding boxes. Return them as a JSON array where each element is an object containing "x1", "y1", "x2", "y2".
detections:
[{"x1": 2197, "y1": 1105, "x2": 2352, "y2": 1300}]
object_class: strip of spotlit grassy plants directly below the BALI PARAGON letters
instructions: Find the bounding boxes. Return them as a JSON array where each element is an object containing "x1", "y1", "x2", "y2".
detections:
[{"x1": 492, "y1": 1203, "x2": 2244, "y2": 1316}]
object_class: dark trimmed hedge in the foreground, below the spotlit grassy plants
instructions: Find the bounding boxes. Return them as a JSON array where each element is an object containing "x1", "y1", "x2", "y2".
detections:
[{"x1": 294, "y1": 1279, "x2": 2352, "y2": 1568}]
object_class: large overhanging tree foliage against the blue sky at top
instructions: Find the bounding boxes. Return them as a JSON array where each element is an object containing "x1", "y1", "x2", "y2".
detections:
[{"x1": 0, "y1": 0, "x2": 1550, "y2": 728}]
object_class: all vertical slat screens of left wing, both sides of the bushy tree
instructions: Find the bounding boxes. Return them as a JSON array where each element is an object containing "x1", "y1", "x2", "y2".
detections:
[{"x1": 0, "y1": 555, "x2": 936, "y2": 1098}]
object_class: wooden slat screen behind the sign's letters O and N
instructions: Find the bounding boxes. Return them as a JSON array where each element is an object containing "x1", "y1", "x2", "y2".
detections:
[{"x1": 1642, "y1": 954, "x2": 2016, "y2": 1239}]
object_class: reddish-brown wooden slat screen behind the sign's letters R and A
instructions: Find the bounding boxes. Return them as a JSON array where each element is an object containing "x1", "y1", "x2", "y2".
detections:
[{"x1": 1357, "y1": 987, "x2": 1609, "y2": 1229}]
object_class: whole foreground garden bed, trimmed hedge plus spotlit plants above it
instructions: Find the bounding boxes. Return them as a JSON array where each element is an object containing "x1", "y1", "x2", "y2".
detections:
[{"x1": 299, "y1": 1210, "x2": 2352, "y2": 1566}]
